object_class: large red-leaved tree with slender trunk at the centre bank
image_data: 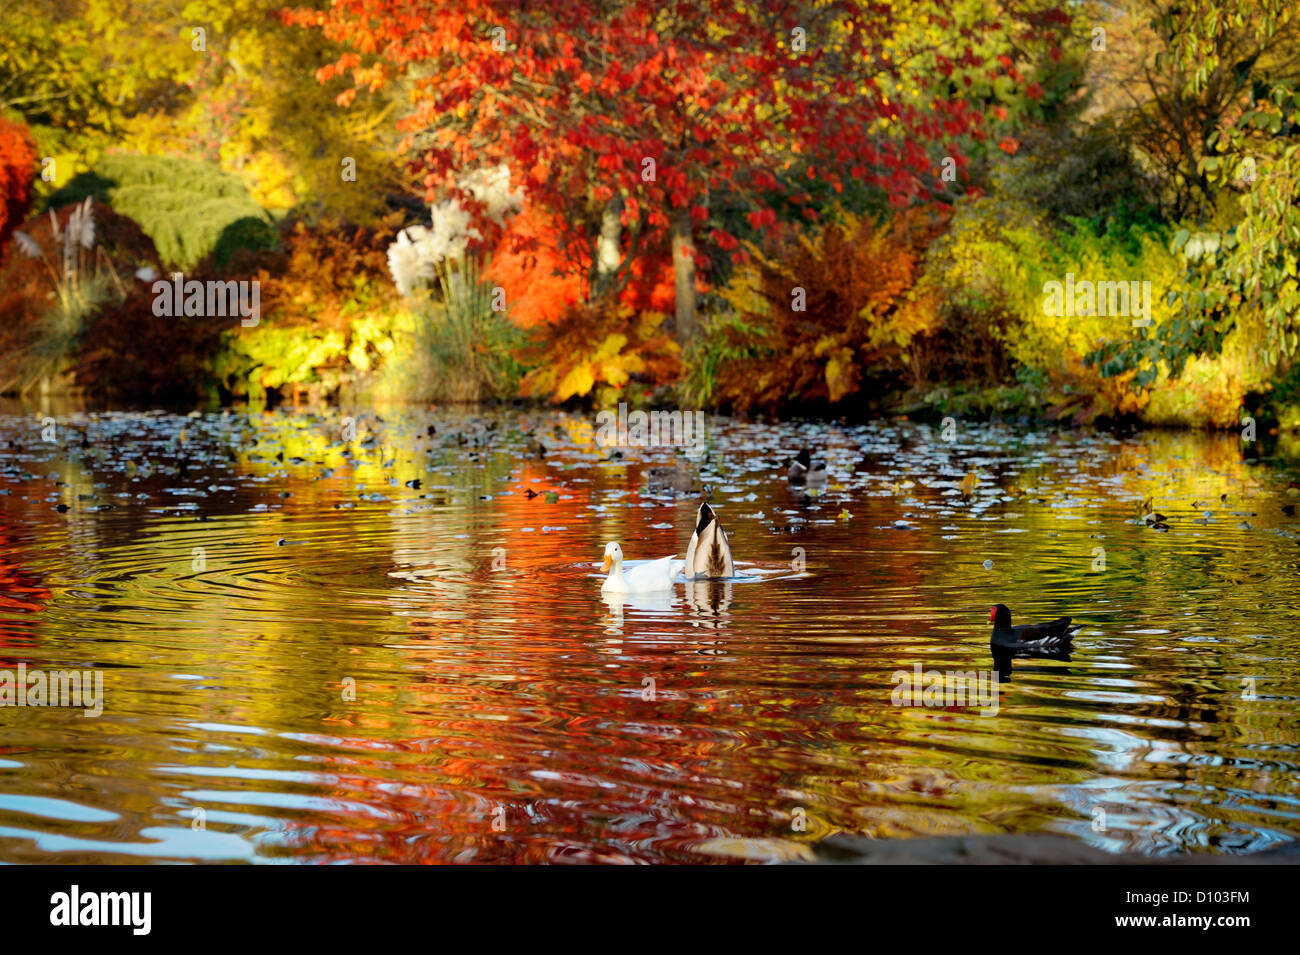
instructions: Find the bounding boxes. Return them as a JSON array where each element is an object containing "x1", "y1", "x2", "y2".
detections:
[{"x1": 294, "y1": 0, "x2": 1065, "y2": 338}]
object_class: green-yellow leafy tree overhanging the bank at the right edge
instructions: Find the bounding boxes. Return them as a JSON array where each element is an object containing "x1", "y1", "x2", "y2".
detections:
[{"x1": 1092, "y1": 0, "x2": 1300, "y2": 387}]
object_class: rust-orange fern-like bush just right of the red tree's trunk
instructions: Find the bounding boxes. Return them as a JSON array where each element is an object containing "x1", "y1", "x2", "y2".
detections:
[{"x1": 716, "y1": 210, "x2": 941, "y2": 412}]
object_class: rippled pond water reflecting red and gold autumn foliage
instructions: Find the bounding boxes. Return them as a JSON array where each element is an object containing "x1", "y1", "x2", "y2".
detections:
[{"x1": 0, "y1": 407, "x2": 1300, "y2": 863}]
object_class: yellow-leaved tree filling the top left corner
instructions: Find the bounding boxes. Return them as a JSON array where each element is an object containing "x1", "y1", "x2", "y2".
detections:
[{"x1": 0, "y1": 0, "x2": 402, "y2": 222}]
